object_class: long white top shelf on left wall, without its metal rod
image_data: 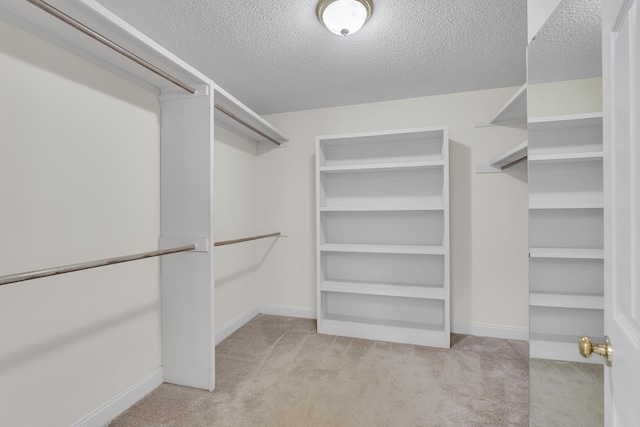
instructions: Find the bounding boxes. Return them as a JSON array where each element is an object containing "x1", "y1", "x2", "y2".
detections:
[{"x1": 0, "y1": 0, "x2": 287, "y2": 147}]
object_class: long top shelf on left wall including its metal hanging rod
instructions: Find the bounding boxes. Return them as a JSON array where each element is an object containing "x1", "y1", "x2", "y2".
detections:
[{"x1": 10, "y1": 0, "x2": 287, "y2": 149}]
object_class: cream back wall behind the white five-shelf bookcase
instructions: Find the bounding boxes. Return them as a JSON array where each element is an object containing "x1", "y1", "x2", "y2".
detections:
[{"x1": 256, "y1": 88, "x2": 528, "y2": 329}]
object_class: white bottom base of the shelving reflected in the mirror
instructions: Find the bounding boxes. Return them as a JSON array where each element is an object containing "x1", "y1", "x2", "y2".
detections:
[{"x1": 529, "y1": 333, "x2": 604, "y2": 365}]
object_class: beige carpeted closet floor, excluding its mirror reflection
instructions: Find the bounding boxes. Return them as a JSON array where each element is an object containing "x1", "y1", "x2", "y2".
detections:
[{"x1": 110, "y1": 315, "x2": 529, "y2": 427}]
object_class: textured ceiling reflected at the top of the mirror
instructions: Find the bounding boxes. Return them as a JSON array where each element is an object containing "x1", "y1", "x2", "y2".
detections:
[{"x1": 528, "y1": 0, "x2": 602, "y2": 84}]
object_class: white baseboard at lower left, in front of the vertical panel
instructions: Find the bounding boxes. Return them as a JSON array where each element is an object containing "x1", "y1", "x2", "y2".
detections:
[{"x1": 72, "y1": 368, "x2": 163, "y2": 427}]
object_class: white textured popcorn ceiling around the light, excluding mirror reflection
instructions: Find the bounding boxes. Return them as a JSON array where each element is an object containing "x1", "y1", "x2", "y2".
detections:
[{"x1": 98, "y1": 0, "x2": 527, "y2": 114}]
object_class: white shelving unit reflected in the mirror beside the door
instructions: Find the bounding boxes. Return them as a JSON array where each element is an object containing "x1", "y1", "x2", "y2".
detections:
[{"x1": 528, "y1": 114, "x2": 604, "y2": 363}]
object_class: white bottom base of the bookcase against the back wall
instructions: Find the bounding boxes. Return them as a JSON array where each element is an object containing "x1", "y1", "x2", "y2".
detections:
[{"x1": 318, "y1": 314, "x2": 451, "y2": 348}]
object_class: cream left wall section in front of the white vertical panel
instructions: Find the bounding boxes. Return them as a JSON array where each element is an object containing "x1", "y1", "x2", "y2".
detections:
[{"x1": 0, "y1": 21, "x2": 161, "y2": 427}]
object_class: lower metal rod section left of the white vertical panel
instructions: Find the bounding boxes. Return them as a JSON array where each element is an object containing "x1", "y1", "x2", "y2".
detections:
[{"x1": 0, "y1": 244, "x2": 196, "y2": 286}]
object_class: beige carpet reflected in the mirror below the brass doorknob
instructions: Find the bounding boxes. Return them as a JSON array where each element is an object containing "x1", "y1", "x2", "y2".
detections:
[{"x1": 530, "y1": 359, "x2": 604, "y2": 427}]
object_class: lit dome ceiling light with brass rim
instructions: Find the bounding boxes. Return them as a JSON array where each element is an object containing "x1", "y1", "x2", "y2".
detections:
[{"x1": 316, "y1": 0, "x2": 373, "y2": 36}]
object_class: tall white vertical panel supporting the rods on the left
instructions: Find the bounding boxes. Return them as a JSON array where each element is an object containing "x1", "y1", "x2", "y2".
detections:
[{"x1": 160, "y1": 87, "x2": 215, "y2": 390}]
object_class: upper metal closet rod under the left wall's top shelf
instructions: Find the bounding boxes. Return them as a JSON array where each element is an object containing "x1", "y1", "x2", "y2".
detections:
[{"x1": 27, "y1": 0, "x2": 282, "y2": 146}]
